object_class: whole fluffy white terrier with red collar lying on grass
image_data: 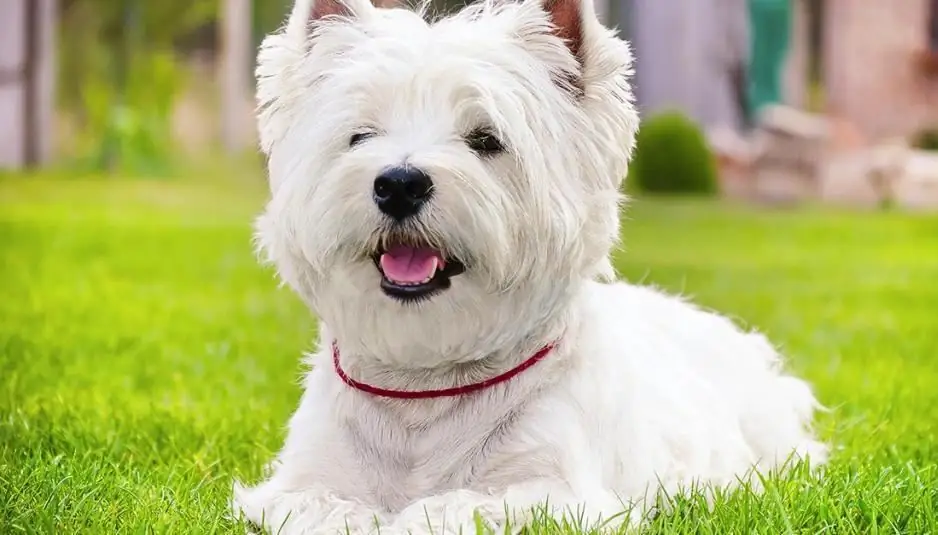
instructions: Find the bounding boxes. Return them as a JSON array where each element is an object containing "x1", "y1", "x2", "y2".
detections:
[{"x1": 234, "y1": 0, "x2": 826, "y2": 534}]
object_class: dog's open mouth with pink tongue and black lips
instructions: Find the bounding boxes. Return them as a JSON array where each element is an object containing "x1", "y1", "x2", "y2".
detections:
[{"x1": 374, "y1": 244, "x2": 466, "y2": 301}]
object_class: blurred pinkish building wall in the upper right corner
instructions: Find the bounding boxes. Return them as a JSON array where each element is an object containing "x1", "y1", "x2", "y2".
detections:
[{"x1": 828, "y1": 0, "x2": 938, "y2": 140}]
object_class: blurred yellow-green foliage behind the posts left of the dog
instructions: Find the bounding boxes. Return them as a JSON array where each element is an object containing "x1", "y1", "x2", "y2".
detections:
[{"x1": 59, "y1": 0, "x2": 289, "y2": 174}]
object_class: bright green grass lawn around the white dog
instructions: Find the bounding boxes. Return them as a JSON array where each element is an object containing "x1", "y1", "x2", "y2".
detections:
[{"x1": 0, "y1": 177, "x2": 938, "y2": 534}]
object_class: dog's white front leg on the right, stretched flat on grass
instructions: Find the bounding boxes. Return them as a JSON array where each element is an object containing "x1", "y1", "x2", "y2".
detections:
[{"x1": 382, "y1": 479, "x2": 637, "y2": 535}]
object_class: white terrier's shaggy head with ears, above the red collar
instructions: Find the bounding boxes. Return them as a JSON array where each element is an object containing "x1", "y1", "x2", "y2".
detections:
[{"x1": 257, "y1": 0, "x2": 638, "y2": 366}]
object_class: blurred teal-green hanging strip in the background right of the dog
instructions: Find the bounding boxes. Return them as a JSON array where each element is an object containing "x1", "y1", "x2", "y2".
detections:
[{"x1": 747, "y1": 0, "x2": 788, "y2": 115}]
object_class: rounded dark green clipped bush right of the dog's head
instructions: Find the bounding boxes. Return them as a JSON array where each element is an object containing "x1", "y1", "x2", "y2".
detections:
[{"x1": 627, "y1": 112, "x2": 718, "y2": 195}]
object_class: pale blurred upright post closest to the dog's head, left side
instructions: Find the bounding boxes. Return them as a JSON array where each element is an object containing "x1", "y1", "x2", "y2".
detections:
[{"x1": 218, "y1": 0, "x2": 252, "y2": 154}]
